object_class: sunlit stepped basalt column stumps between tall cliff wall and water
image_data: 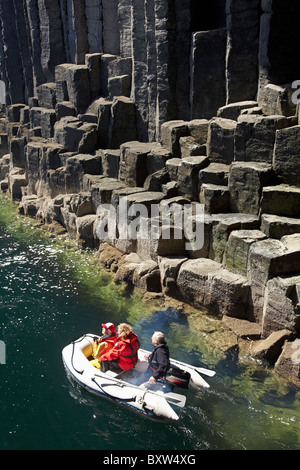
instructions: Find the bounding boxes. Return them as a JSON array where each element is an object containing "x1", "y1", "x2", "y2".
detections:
[{"x1": 1, "y1": 95, "x2": 300, "y2": 382}]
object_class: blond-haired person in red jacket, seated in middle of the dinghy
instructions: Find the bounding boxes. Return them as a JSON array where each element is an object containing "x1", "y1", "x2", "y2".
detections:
[{"x1": 99, "y1": 323, "x2": 140, "y2": 372}]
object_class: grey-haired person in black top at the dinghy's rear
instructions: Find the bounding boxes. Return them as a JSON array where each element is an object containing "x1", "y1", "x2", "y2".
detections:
[{"x1": 142, "y1": 331, "x2": 170, "y2": 388}]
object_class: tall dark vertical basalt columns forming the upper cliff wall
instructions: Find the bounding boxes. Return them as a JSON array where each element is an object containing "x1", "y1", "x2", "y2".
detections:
[{"x1": 4, "y1": 0, "x2": 299, "y2": 141}]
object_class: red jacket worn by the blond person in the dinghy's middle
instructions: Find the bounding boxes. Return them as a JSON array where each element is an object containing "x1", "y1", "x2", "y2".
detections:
[{"x1": 99, "y1": 333, "x2": 140, "y2": 370}]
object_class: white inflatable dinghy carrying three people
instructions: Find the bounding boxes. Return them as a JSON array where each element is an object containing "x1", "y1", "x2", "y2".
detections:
[{"x1": 62, "y1": 334, "x2": 215, "y2": 421}]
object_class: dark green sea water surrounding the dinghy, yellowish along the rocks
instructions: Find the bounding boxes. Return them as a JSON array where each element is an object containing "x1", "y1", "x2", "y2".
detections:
[{"x1": 0, "y1": 196, "x2": 300, "y2": 451}]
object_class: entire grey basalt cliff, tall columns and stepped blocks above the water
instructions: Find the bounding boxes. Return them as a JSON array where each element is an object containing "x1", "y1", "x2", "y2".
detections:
[{"x1": 0, "y1": 0, "x2": 300, "y2": 383}]
